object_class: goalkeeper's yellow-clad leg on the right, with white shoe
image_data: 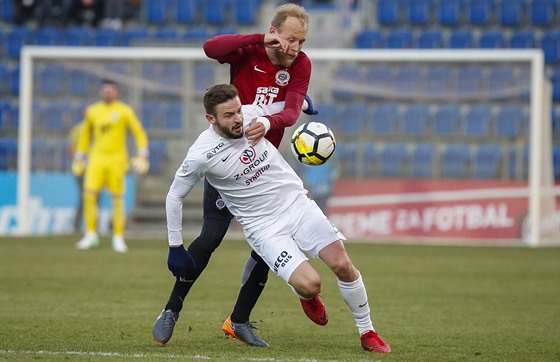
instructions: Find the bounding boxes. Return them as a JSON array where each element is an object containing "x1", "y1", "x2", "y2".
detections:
[{"x1": 107, "y1": 163, "x2": 128, "y2": 253}]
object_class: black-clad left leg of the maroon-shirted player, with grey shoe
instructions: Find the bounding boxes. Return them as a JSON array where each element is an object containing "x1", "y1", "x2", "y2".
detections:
[{"x1": 152, "y1": 180, "x2": 233, "y2": 344}]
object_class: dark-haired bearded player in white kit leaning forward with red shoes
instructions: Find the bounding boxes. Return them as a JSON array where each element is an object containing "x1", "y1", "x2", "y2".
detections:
[{"x1": 166, "y1": 84, "x2": 391, "y2": 353}]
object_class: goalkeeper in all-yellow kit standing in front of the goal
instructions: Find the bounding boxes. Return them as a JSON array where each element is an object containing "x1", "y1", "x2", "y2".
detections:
[{"x1": 72, "y1": 80, "x2": 150, "y2": 253}]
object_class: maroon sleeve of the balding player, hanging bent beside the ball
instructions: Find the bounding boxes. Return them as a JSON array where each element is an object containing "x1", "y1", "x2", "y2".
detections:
[{"x1": 266, "y1": 53, "x2": 311, "y2": 129}]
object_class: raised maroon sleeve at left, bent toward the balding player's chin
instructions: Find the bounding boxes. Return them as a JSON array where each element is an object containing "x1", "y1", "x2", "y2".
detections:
[{"x1": 202, "y1": 34, "x2": 264, "y2": 64}]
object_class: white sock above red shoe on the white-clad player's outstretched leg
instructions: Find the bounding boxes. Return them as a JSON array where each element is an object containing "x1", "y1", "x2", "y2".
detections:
[{"x1": 337, "y1": 275, "x2": 375, "y2": 335}]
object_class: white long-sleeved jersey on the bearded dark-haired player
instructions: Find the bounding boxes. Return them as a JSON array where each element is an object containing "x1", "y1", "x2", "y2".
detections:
[{"x1": 166, "y1": 102, "x2": 307, "y2": 245}]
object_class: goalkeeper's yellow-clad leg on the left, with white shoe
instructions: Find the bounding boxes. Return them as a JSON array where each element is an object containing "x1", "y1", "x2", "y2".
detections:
[{"x1": 76, "y1": 157, "x2": 105, "y2": 250}]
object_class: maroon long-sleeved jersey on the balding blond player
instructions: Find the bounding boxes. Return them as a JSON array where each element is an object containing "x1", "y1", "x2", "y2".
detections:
[{"x1": 204, "y1": 34, "x2": 311, "y2": 147}]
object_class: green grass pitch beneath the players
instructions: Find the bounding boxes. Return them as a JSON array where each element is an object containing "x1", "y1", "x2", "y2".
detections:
[{"x1": 0, "y1": 237, "x2": 560, "y2": 362}]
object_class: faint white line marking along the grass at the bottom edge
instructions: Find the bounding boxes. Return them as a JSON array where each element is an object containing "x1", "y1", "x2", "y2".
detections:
[{"x1": 0, "y1": 348, "x2": 350, "y2": 362}]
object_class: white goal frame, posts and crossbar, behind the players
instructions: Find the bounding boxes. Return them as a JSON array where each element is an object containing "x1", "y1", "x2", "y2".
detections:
[{"x1": 17, "y1": 46, "x2": 559, "y2": 246}]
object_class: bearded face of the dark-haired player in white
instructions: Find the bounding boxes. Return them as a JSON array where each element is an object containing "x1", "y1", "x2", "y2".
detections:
[{"x1": 206, "y1": 97, "x2": 243, "y2": 139}]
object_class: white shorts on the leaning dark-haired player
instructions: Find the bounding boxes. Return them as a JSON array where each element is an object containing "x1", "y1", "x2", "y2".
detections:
[{"x1": 245, "y1": 195, "x2": 346, "y2": 282}]
